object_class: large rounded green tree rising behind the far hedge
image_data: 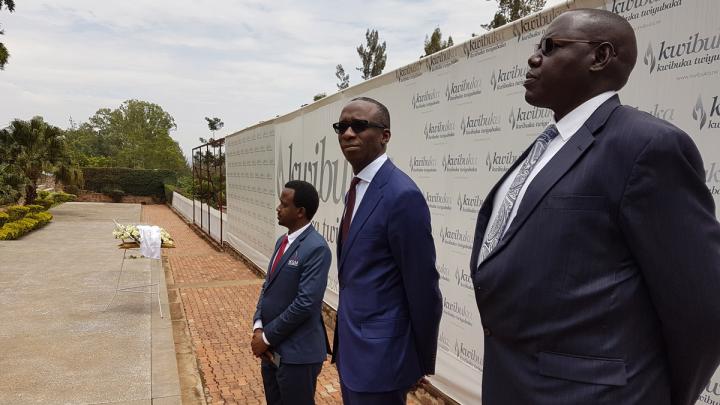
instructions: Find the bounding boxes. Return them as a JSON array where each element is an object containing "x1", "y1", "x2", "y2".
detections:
[{"x1": 69, "y1": 100, "x2": 189, "y2": 174}]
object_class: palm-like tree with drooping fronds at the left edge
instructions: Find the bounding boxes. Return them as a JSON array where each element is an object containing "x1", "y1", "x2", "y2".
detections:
[{"x1": 0, "y1": 117, "x2": 67, "y2": 204}]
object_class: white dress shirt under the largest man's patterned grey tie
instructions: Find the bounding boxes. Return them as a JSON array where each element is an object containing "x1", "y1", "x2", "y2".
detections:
[{"x1": 478, "y1": 91, "x2": 617, "y2": 264}]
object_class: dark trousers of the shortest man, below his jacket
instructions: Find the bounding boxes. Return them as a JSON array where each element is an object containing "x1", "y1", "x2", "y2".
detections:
[{"x1": 260, "y1": 359, "x2": 322, "y2": 405}]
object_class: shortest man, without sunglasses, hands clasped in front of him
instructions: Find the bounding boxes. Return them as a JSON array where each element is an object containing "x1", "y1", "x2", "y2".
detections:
[{"x1": 251, "y1": 180, "x2": 331, "y2": 405}]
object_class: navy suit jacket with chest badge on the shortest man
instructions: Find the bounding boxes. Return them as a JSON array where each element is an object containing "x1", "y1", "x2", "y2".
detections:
[{"x1": 253, "y1": 225, "x2": 332, "y2": 364}]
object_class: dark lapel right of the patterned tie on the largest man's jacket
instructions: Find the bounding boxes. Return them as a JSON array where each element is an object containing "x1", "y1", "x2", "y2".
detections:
[{"x1": 481, "y1": 95, "x2": 620, "y2": 264}]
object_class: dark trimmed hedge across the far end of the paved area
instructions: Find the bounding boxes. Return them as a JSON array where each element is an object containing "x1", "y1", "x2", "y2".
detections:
[{"x1": 82, "y1": 167, "x2": 177, "y2": 199}]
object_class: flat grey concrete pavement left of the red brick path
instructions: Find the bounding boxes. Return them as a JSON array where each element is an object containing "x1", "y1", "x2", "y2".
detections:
[{"x1": 0, "y1": 203, "x2": 181, "y2": 405}]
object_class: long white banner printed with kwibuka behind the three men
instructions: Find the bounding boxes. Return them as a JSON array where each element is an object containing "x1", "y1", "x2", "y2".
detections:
[{"x1": 227, "y1": 0, "x2": 720, "y2": 404}]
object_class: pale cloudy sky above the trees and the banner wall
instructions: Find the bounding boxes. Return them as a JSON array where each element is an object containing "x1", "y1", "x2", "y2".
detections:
[{"x1": 0, "y1": 0, "x2": 564, "y2": 161}]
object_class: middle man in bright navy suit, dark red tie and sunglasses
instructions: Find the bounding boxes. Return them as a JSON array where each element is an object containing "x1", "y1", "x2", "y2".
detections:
[{"x1": 333, "y1": 97, "x2": 442, "y2": 405}]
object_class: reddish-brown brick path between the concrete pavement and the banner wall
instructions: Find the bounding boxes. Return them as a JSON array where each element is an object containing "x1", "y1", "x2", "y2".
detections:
[{"x1": 142, "y1": 205, "x2": 344, "y2": 405}]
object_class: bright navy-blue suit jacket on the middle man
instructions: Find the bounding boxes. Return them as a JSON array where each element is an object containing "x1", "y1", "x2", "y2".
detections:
[{"x1": 333, "y1": 160, "x2": 442, "y2": 392}]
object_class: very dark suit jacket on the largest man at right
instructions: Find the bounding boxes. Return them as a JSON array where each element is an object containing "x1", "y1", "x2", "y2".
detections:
[{"x1": 470, "y1": 96, "x2": 720, "y2": 405}]
